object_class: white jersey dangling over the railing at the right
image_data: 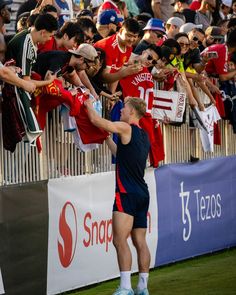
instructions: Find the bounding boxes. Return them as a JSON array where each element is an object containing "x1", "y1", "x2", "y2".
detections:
[{"x1": 196, "y1": 105, "x2": 221, "y2": 152}]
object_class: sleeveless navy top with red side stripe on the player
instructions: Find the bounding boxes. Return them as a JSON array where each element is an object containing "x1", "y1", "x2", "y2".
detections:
[{"x1": 116, "y1": 125, "x2": 150, "y2": 195}]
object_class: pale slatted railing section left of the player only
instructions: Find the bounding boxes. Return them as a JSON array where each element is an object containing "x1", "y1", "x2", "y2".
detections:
[{"x1": 0, "y1": 108, "x2": 113, "y2": 185}]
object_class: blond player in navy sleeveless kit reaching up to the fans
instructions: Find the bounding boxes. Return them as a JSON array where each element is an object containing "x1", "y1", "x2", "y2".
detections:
[{"x1": 85, "y1": 97, "x2": 150, "y2": 295}]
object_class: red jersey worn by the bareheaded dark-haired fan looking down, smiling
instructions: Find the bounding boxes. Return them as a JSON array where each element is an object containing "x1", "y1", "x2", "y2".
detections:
[{"x1": 94, "y1": 34, "x2": 132, "y2": 73}]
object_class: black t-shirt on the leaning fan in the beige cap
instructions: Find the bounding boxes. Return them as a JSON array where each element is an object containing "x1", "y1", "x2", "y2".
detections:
[{"x1": 33, "y1": 50, "x2": 74, "y2": 78}]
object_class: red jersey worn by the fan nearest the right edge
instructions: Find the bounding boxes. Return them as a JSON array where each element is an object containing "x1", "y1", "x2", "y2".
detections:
[{"x1": 203, "y1": 44, "x2": 228, "y2": 75}]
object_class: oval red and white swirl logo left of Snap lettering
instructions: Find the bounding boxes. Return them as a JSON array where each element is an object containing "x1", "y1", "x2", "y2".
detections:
[{"x1": 57, "y1": 202, "x2": 78, "y2": 268}]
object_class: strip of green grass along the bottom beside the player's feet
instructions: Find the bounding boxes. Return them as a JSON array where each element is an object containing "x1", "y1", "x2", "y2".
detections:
[{"x1": 66, "y1": 248, "x2": 236, "y2": 295}]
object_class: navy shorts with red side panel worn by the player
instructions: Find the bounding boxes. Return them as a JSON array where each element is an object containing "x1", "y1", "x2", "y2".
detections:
[{"x1": 113, "y1": 192, "x2": 149, "y2": 228}]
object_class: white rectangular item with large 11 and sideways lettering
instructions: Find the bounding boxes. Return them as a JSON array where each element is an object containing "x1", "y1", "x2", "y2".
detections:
[{"x1": 152, "y1": 89, "x2": 186, "y2": 122}]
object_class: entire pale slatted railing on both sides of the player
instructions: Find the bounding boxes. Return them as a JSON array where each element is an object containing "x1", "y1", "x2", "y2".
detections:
[{"x1": 0, "y1": 101, "x2": 236, "y2": 185}]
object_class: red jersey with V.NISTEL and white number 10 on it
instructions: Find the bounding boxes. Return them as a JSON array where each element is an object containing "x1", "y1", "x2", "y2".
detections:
[{"x1": 120, "y1": 68, "x2": 154, "y2": 113}]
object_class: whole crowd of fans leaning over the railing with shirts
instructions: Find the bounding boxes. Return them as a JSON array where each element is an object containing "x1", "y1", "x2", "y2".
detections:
[{"x1": 0, "y1": 0, "x2": 236, "y2": 167}]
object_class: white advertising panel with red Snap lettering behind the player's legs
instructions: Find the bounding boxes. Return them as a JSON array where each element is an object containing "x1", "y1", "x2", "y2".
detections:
[{"x1": 47, "y1": 169, "x2": 157, "y2": 294}]
